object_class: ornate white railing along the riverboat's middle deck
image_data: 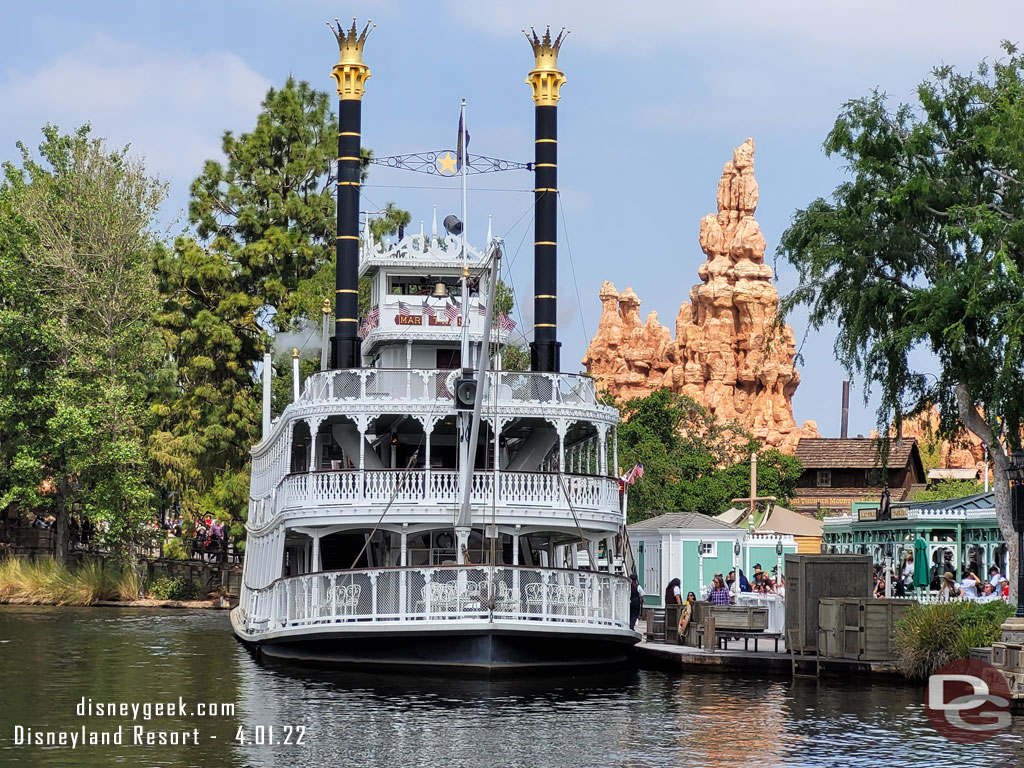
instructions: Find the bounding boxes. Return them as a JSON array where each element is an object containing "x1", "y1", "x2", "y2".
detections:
[{"x1": 250, "y1": 469, "x2": 620, "y2": 525}]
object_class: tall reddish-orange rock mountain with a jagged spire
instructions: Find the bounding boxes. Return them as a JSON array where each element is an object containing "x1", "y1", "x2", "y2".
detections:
[{"x1": 583, "y1": 139, "x2": 818, "y2": 454}]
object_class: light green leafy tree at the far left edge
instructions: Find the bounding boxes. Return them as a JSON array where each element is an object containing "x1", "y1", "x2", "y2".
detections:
[{"x1": 0, "y1": 126, "x2": 165, "y2": 559}]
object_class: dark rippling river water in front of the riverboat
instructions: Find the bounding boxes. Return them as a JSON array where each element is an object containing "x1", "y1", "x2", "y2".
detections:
[{"x1": 0, "y1": 606, "x2": 1024, "y2": 768}]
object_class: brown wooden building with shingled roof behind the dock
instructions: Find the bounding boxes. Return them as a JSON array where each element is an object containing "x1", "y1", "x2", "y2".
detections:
[{"x1": 791, "y1": 437, "x2": 927, "y2": 516}]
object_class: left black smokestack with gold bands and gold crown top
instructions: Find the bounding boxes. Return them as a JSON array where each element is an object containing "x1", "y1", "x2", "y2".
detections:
[{"x1": 328, "y1": 18, "x2": 370, "y2": 368}]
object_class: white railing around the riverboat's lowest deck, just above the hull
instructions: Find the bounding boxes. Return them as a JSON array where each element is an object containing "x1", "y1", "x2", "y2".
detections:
[{"x1": 244, "y1": 565, "x2": 630, "y2": 637}]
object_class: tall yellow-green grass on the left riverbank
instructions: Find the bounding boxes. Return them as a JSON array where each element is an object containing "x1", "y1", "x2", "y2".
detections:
[{"x1": 0, "y1": 557, "x2": 141, "y2": 605}]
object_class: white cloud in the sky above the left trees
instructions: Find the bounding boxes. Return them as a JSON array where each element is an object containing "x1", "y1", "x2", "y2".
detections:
[{"x1": 0, "y1": 36, "x2": 269, "y2": 205}]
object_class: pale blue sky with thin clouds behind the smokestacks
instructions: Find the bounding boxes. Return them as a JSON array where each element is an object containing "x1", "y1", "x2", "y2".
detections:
[{"x1": 0, "y1": 0, "x2": 1024, "y2": 437}]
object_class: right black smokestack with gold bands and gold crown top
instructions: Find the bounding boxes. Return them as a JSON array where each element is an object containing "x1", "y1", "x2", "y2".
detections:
[{"x1": 523, "y1": 27, "x2": 568, "y2": 372}]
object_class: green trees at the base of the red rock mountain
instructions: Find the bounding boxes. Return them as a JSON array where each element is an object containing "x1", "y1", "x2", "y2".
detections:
[{"x1": 606, "y1": 389, "x2": 801, "y2": 522}]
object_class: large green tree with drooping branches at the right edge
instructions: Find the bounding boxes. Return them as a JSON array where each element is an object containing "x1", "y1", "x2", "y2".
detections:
[{"x1": 778, "y1": 44, "x2": 1024, "y2": 602}]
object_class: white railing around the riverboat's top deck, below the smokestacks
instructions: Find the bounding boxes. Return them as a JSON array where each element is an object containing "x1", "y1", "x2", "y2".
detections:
[{"x1": 299, "y1": 368, "x2": 597, "y2": 406}]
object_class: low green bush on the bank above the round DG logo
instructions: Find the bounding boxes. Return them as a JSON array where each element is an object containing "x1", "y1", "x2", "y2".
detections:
[{"x1": 896, "y1": 600, "x2": 1014, "y2": 679}]
